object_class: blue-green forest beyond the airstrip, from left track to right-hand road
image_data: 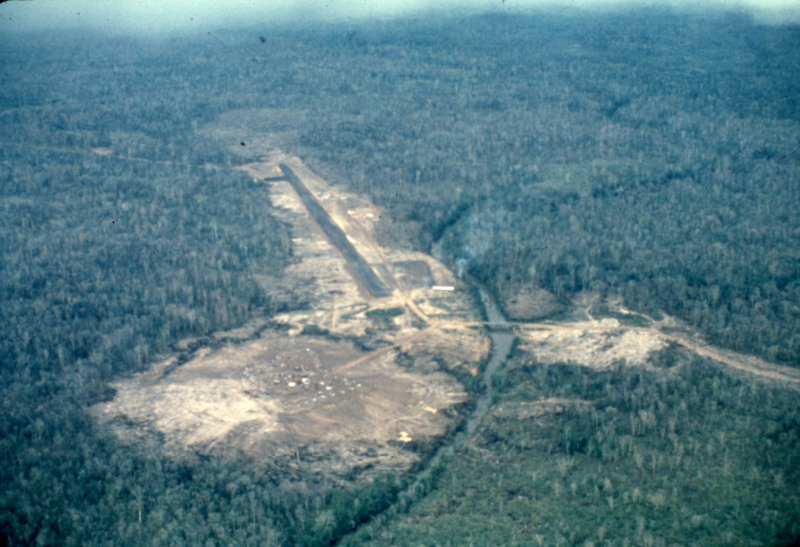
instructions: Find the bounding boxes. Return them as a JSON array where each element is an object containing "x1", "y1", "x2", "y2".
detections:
[{"x1": 9, "y1": 15, "x2": 800, "y2": 365}]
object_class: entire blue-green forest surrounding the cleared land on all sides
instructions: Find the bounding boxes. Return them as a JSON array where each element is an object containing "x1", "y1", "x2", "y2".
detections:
[{"x1": 0, "y1": 8, "x2": 800, "y2": 546}]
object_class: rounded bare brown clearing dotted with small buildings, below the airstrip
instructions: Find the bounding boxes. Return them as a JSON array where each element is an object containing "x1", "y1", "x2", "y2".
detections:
[{"x1": 93, "y1": 333, "x2": 466, "y2": 482}]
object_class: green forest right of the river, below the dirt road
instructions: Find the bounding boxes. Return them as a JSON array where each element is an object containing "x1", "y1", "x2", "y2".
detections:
[{"x1": 342, "y1": 354, "x2": 800, "y2": 546}]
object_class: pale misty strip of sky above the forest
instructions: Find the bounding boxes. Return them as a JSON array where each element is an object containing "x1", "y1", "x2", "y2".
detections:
[{"x1": 0, "y1": 0, "x2": 800, "y2": 35}]
